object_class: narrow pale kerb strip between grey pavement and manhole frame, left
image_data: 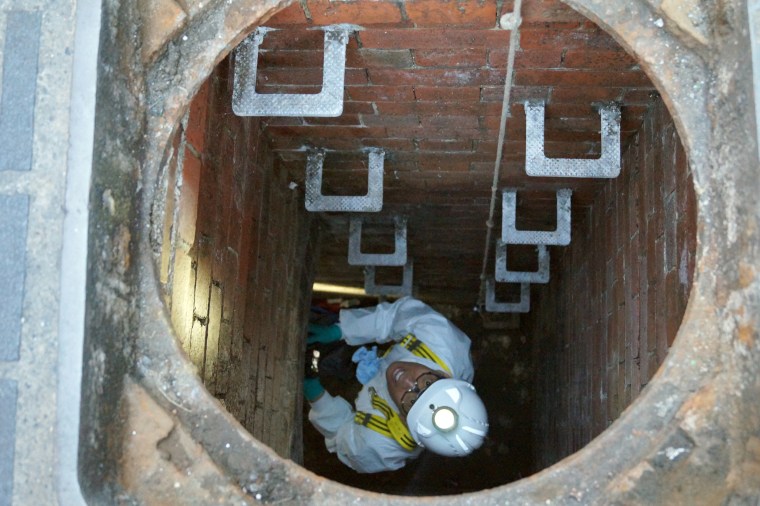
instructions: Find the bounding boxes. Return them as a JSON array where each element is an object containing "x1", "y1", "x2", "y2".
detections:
[{"x1": 56, "y1": 0, "x2": 101, "y2": 506}]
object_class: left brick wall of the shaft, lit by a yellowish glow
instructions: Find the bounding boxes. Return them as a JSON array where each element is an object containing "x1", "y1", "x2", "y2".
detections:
[{"x1": 161, "y1": 56, "x2": 316, "y2": 459}]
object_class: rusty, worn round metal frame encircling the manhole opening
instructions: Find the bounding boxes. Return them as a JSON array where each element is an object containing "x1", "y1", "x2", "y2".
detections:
[{"x1": 84, "y1": 0, "x2": 760, "y2": 504}]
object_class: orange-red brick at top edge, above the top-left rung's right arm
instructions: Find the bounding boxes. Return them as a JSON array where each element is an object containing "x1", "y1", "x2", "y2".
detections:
[{"x1": 308, "y1": 0, "x2": 402, "y2": 26}]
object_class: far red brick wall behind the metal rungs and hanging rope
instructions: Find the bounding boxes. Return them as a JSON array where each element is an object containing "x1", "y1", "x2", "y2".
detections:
[{"x1": 257, "y1": 0, "x2": 655, "y2": 309}]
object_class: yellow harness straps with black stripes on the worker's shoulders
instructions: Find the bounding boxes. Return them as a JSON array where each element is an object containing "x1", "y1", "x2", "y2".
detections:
[{"x1": 354, "y1": 334, "x2": 451, "y2": 451}]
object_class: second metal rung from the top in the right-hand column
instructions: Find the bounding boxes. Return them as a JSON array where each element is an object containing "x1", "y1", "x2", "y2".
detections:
[{"x1": 501, "y1": 188, "x2": 573, "y2": 246}]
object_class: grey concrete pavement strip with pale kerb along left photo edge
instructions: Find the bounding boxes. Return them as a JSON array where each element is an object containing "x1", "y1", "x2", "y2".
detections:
[{"x1": 0, "y1": 0, "x2": 100, "y2": 506}]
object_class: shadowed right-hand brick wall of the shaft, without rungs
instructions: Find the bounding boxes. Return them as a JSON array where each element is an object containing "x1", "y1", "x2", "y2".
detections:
[{"x1": 526, "y1": 97, "x2": 696, "y2": 467}]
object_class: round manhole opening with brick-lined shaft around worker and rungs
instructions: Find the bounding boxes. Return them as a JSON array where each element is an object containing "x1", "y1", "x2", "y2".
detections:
[{"x1": 147, "y1": 2, "x2": 696, "y2": 495}]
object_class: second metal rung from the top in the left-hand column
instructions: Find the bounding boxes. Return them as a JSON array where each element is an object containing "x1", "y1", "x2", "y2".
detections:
[{"x1": 306, "y1": 149, "x2": 385, "y2": 213}]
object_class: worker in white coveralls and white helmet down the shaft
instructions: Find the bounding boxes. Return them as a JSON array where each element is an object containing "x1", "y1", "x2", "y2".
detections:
[{"x1": 304, "y1": 297, "x2": 488, "y2": 473}]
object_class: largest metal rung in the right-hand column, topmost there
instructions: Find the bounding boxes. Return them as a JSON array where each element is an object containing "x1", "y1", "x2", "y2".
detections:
[{"x1": 525, "y1": 100, "x2": 620, "y2": 178}]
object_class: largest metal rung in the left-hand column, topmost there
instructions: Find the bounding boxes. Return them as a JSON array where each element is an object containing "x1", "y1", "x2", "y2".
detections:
[{"x1": 232, "y1": 25, "x2": 355, "y2": 117}]
